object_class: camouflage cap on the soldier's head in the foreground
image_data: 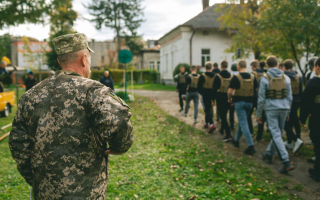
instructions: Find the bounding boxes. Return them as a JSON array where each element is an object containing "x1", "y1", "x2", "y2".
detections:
[{"x1": 52, "y1": 33, "x2": 94, "y2": 55}]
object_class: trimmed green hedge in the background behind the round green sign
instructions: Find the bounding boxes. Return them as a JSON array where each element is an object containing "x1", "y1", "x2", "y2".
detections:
[{"x1": 91, "y1": 69, "x2": 158, "y2": 84}]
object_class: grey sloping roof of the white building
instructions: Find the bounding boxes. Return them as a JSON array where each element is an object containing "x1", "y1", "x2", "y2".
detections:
[{"x1": 182, "y1": 4, "x2": 221, "y2": 29}]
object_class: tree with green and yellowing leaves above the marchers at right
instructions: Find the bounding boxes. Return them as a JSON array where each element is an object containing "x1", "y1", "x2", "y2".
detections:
[{"x1": 260, "y1": 0, "x2": 320, "y2": 82}]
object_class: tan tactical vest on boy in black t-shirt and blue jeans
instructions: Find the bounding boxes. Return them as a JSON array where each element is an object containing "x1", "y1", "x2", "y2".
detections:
[{"x1": 234, "y1": 73, "x2": 254, "y2": 97}]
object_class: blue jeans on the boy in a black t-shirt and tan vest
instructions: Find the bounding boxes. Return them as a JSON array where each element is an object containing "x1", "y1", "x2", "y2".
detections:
[{"x1": 234, "y1": 101, "x2": 253, "y2": 146}]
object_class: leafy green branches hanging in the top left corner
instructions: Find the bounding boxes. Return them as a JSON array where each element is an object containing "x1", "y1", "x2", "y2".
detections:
[{"x1": 0, "y1": 0, "x2": 52, "y2": 29}]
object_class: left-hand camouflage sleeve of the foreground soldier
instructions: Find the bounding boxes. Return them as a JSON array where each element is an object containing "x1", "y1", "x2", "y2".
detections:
[{"x1": 9, "y1": 98, "x2": 34, "y2": 186}]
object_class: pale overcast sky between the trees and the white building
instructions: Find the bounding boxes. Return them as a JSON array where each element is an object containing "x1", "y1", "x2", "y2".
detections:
[{"x1": 0, "y1": 0, "x2": 225, "y2": 41}]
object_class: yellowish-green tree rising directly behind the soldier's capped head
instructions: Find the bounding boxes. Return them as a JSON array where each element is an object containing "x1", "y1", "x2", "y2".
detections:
[{"x1": 46, "y1": 0, "x2": 78, "y2": 70}]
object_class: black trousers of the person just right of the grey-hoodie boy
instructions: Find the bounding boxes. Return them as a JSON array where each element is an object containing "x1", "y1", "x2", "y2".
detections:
[{"x1": 284, "y1": 102, "x2": 301, "y2": 144}]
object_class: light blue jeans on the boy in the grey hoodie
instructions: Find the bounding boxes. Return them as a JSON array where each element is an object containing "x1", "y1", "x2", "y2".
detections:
[{"x1": 266, "y1": 110, "x2": 289, "y2": 162}]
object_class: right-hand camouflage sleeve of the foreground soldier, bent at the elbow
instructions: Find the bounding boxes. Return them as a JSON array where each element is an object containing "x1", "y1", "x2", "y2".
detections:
[{"x1": 87, "y1": 85, "x2": 133, "y2": 153}]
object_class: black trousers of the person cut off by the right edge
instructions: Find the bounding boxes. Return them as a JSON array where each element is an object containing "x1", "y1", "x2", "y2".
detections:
[{"x1": 309, "y1": 117, "x2": 320, "y2": 178}]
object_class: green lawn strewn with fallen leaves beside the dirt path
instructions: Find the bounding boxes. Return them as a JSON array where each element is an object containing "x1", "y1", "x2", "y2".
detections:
[{"x1": 0, "y1": 97, "x2": 301, "y2": 200}]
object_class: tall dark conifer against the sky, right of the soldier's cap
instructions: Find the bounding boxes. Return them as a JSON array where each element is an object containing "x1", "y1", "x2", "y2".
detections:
[{"x1": 85, "y1": 0, "x2": 143, "y2": 57}]
